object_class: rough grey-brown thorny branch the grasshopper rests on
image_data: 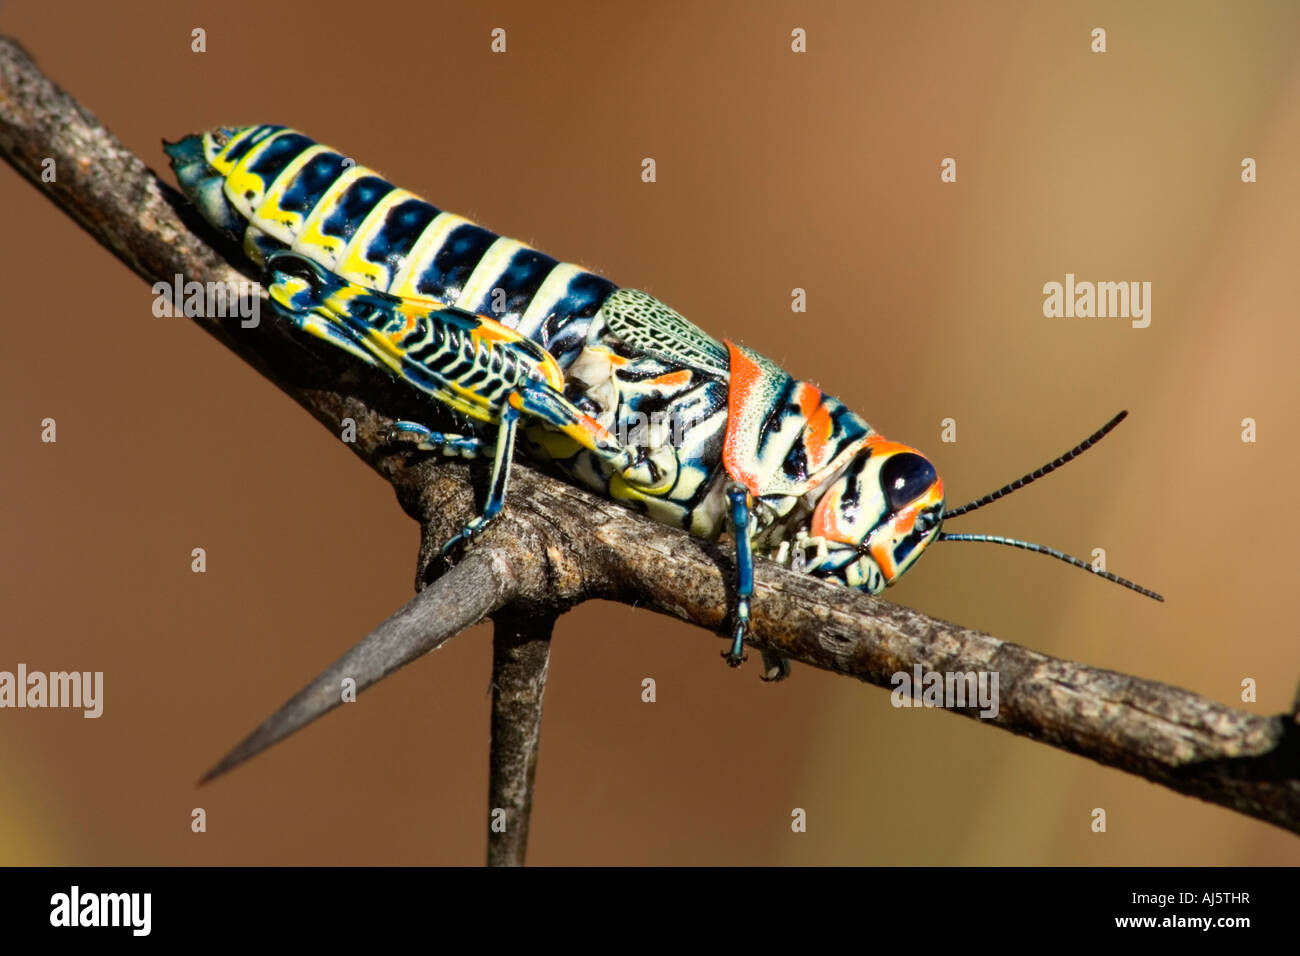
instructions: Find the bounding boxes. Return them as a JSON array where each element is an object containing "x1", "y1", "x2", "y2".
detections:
[{"x1": 0, "y1": 39, "x2": 1300, "y2": 862}]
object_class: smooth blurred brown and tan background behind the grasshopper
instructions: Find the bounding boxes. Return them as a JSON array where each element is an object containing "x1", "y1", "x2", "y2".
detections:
[{"x1": 0, "y1": 0, "x2": 1300, "y2": 864}]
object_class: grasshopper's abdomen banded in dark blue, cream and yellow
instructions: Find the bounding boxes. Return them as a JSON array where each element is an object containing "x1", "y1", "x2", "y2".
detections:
[{"x1": 166, "y1": 126, "x2": 616, "y2": 365}]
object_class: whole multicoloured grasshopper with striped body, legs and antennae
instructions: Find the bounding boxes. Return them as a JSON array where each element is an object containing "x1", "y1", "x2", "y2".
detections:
[{"x1": 166, "y1": 126, "x2": 1162, "y2": 679}]
